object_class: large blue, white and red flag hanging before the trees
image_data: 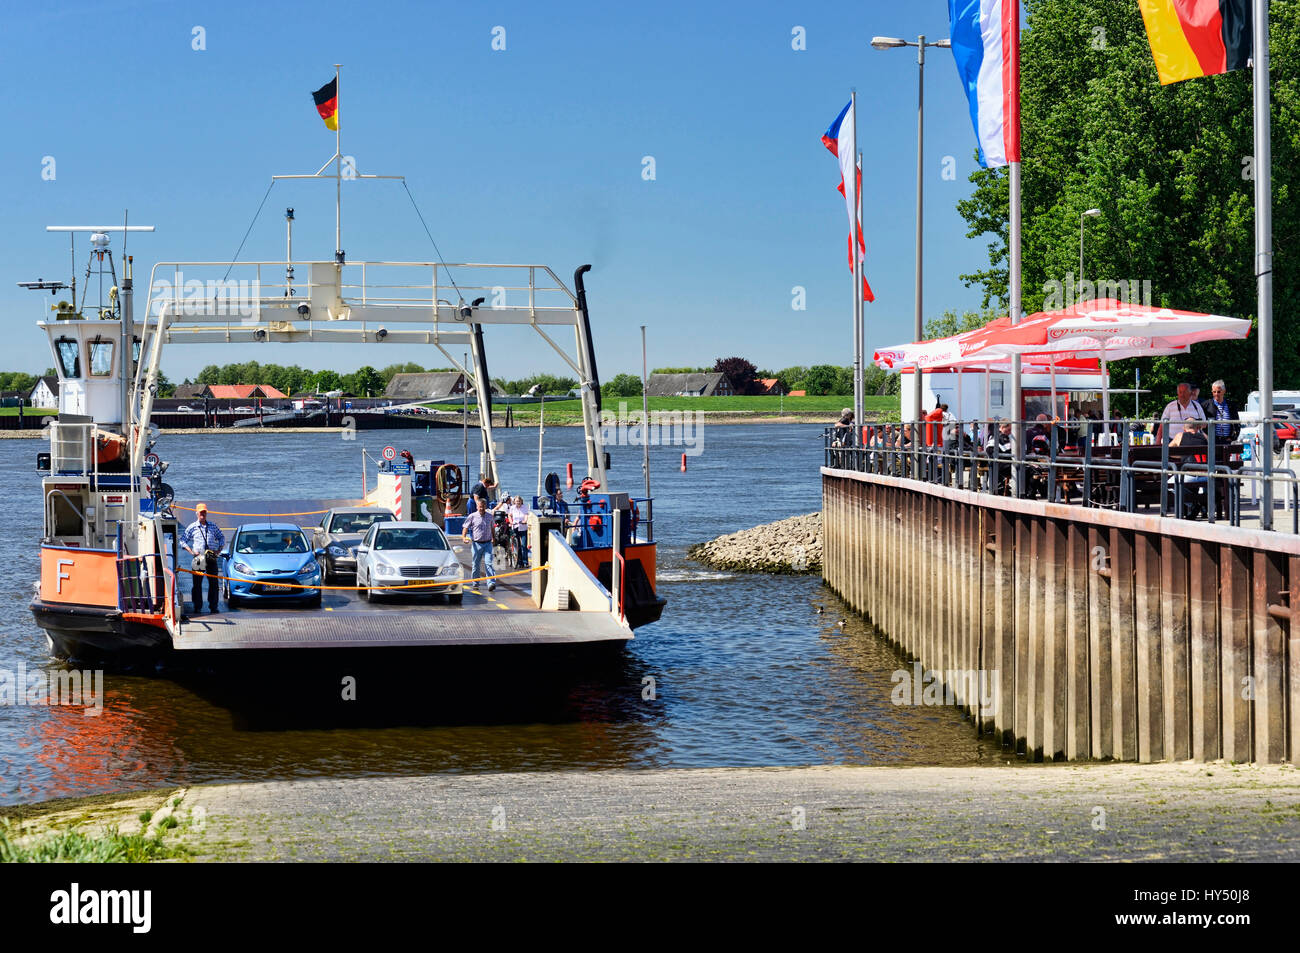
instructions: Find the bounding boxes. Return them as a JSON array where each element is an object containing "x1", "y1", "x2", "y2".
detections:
[{"x1": 948, "y1": 0, "x2": 1021, "y2": 169}]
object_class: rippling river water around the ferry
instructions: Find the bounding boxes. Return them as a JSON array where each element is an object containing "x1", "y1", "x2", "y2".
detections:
[{"x1": 0, "y1": 424, "x2": 1006, "y2": 803}]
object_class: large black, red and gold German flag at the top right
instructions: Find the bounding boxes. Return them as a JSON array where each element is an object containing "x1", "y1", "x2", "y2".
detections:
[{"x1": 1138, "y1": 0, "x2": 1252, "y2": 86}]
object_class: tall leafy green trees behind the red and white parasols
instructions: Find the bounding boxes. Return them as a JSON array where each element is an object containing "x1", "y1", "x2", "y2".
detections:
[{"x1": 958, "y1": 0, "x2": 1300, "y2": 399}]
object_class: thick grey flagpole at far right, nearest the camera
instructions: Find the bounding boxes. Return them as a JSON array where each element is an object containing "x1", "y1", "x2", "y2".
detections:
[{"x1": 1252, "y1": 0, "x2": 1273, "y2": 529}]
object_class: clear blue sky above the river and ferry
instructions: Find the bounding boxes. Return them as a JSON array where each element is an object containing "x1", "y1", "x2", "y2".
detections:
[{"x1": 0, "y1": 0, "x2": 988, "y2": 381}]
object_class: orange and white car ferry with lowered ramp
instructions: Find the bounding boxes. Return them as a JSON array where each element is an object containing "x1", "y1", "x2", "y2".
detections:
[{"x1": 23, "y1": 154, "x2": 664, "y2": 659}]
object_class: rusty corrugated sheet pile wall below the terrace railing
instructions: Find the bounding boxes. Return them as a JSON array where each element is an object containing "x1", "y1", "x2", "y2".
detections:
[{"x1": 822, "y1": 468, "x2": 1300, "y2": 763}]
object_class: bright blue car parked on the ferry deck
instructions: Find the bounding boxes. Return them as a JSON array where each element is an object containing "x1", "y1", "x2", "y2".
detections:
[{"x1": 221, "y1": 523, "x2": 321, "y2": 608}]
